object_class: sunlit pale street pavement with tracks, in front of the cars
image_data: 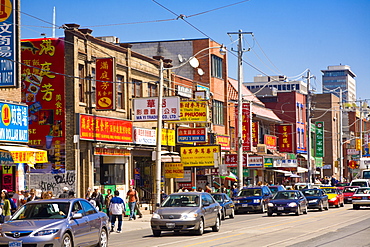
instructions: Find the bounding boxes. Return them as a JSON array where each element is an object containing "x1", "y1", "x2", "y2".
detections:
[{"x1": 109, "y1": 204, "x2": 370, "y2": 247}]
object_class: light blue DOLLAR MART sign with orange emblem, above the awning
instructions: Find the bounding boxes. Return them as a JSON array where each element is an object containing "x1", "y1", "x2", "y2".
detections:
[{"x1": 0, "y1": 102, "x2": 28, "y2": 143}]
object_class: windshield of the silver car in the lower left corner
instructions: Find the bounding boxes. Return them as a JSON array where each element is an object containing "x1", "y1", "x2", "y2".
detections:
[{"x1": 12, "y1": 202, "x2": 70, "y2": 220}]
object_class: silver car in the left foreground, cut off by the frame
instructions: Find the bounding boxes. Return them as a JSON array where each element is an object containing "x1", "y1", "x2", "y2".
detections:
[{"x1": 0, "y1": 198, "x2": 110, "y2": 247}]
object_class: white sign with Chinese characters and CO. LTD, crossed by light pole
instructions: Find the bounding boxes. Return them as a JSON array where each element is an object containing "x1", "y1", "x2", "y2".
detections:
[{"x1": 134, "y1": 97, "x2": 180, "y2": 121}]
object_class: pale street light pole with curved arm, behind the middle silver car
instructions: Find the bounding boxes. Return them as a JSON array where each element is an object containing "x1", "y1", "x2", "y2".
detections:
[{"x1": 154, "y1": 45, "x2": 226, "y2": 205}]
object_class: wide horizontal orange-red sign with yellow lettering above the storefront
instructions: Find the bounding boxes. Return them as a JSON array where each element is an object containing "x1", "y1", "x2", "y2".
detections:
[{"x1": 80, "y1": 114, "x2": 132, "y2": 143}]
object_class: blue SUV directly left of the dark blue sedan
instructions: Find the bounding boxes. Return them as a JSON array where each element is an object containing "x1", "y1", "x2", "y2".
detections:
[{"x1": 233, "y1": 185, "x2": 273, "y2": 213}]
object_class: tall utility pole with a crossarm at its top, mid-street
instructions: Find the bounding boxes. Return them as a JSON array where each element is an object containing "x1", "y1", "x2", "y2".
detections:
[{"x1": 227, "y1": 30, "x2": 253, "y2": 189}]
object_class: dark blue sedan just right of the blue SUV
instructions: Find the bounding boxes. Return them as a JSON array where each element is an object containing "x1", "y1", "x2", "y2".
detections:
[{"x1": 267, "y1": 190, "x2": 308, "y2": 216}]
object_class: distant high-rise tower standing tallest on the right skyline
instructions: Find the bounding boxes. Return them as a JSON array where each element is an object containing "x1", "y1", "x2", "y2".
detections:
[{"x1": 321, "y1": 65, "x2": 356, "y2": 103}]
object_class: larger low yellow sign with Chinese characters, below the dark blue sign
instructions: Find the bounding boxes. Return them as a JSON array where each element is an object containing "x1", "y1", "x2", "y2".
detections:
[{"x1": 181, "y1": 146, "x2": 220, "y2": 167}]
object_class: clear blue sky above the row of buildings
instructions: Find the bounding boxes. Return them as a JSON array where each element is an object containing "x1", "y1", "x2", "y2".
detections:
[{"x1": 21, "y1": 0, "x2": 370, "y2": 100}]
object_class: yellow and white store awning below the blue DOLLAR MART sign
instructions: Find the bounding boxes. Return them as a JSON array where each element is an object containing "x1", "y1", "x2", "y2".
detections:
[{"x1": 0, "y1": 146, "x2": 48, "y2": 165}]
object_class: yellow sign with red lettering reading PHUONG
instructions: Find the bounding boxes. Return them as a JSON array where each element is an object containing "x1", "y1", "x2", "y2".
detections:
[{"x1": 174, "y1": 101, "x2": 208, "y2": 122}]
